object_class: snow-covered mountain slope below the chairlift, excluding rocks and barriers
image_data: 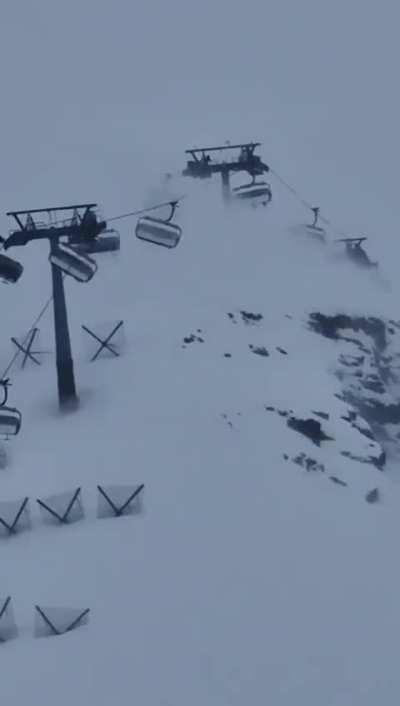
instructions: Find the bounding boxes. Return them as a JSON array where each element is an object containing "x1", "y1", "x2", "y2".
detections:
[{"x1": 0, "y1": 179, "x2": 400, "y2": 706}]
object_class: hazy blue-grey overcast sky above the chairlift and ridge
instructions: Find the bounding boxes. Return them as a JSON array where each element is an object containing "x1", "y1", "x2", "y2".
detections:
[{"x1": 0, "y1": 0, "x2": 400, "y2": 242}]
